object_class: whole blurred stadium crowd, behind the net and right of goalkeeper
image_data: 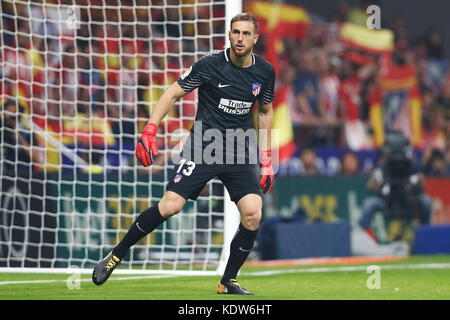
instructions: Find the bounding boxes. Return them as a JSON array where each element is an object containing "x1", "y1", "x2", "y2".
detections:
[{"x1": 0, "y1": 0, "x2": 450, "y2": 176}]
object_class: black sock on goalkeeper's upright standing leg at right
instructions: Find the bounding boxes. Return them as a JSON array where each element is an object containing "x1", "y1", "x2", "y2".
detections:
[{"x1": 220, "y1": 224, "x2": 258, "y2": 283}]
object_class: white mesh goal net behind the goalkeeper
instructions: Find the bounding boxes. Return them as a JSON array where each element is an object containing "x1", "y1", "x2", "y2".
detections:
[{"x1": 0, "y1": 0, "x2": 239, "y2": 272}]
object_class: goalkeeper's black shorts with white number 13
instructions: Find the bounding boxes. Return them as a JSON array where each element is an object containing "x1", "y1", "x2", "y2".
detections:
[{"x1": 166, "y1": 160, "x2": 261, "y2": 203}]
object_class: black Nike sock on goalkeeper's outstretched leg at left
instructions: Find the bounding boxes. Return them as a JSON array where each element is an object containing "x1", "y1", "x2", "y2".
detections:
[{"x1": 113, "y1": 205, "x2": 166, "y2": 259}]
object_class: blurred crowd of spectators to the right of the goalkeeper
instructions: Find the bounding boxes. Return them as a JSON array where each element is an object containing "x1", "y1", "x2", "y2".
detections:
[{"x1": 261, "y1": 1, "x2": 450, "y2": 176}]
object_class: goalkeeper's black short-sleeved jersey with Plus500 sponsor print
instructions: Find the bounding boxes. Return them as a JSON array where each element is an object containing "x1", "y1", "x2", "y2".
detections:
[{"x1": 177, "y1": 48, "x2": 275, "y2": 162}]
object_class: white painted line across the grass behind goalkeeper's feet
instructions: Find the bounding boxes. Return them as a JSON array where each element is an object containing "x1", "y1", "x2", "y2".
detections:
[{"x1": 0, "y1": 263, "x2": 450, "y2": 286}]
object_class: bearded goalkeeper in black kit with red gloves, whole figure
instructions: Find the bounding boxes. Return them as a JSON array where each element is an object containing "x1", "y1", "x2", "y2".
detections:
[{"x1": 92, "y1": 13, "x2": 275, "y2": 295}]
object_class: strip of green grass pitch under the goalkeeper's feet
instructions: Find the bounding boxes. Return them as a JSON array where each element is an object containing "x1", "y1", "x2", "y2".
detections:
[{"x1": 0, "y1": 255, "x2": 450, "y2": 301}]
